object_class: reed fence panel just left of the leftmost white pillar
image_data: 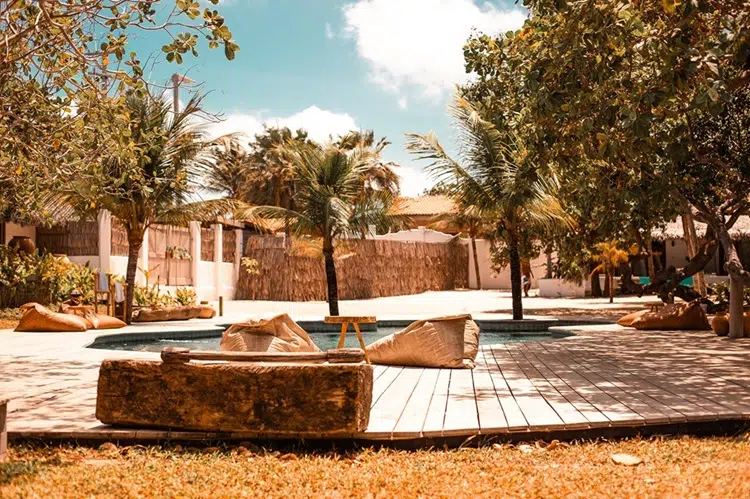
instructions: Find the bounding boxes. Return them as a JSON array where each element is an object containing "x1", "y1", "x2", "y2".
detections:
[{"x1": 36, "y1": 222, "x2": 99, "y2": 256}]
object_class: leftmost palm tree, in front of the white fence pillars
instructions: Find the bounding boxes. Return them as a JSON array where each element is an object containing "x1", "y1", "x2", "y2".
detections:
[{"x1": 62, "y1": 94, "x2": 236, "y2": 322}]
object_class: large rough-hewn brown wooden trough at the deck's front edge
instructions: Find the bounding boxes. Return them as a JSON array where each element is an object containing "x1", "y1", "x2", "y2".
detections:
[{"x1": 96, "y1": 347, "x2": 373, "y2": 437}]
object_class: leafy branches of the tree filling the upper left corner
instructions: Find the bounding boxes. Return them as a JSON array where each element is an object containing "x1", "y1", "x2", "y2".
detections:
[{"x1": 0, "y1": 0, "x2": 239, "y2": 222}]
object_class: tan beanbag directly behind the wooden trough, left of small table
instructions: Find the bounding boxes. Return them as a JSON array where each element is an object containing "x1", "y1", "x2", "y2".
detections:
[{"x1": 220, "y1": 314, "x2": 320, "y2": 352}]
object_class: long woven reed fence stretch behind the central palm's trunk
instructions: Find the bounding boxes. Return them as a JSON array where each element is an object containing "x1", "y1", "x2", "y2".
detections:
[{"x1": 237, "y1": 237, "x2": 469, "y2": 301}]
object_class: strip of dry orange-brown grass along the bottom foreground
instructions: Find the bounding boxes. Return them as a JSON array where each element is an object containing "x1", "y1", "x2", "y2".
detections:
[{"x1": 0, "y1": 436, "x2": 750, "y2": 498}]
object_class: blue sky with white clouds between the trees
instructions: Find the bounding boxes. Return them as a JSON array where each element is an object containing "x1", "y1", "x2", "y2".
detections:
[{"x1": 131, "y1": 0, "x2": 526, "y2": 196}]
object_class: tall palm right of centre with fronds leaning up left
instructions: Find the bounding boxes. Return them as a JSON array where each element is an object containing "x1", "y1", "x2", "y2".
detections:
[{"x1": 407, "y1": 97, "x2": 566, "y2": 320}]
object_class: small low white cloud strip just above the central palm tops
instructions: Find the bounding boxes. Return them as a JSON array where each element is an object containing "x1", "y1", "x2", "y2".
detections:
[{"x1": 208, "y1": 106, "x2": 359, "y2": 142}]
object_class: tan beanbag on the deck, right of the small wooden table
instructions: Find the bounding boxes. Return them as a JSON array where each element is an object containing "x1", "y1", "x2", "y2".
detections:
[{"x1": 367, "y1": 315, "x2": 479, "y2": 369}]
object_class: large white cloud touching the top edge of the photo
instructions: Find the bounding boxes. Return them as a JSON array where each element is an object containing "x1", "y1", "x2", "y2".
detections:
[{"x1": 344, "y1": 0, "x2": 526, "y2": 97}]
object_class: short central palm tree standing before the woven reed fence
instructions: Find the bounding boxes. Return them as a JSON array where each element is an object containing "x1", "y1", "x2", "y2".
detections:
[{"x1": 247, "y1": 144, "x2": 390, "y2": 315}]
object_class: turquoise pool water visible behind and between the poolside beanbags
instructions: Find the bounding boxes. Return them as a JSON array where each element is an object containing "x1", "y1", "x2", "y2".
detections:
[{"x1": 94, "y1": 327, "x2": 552, "y2": 352}]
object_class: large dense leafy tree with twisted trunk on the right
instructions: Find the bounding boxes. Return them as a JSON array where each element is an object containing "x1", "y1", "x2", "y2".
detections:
[{"x1": 465, "y1": 0, "x2": 750, "y2": 336}]
